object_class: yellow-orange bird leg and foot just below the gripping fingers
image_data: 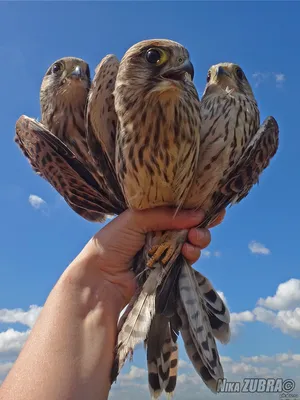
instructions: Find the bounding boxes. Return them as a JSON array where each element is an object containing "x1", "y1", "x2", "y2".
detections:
[{"x1": 147, "y1": 229, "x2": 188, "y2": 268}]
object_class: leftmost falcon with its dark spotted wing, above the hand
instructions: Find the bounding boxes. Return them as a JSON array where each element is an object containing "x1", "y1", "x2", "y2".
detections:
[{"x1": 15, "y1": 57, "x2": 125, "y2": 222}]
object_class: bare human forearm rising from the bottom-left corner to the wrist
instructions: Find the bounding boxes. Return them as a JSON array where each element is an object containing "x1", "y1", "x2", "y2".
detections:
[{"x1": 0, "y1": 256, "x2": 120, "y2": 400}]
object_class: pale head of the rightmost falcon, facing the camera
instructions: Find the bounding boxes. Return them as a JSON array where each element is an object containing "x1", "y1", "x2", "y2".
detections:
[{"x1": 203, "y1": 63, "x2": 254, "y2": 99}]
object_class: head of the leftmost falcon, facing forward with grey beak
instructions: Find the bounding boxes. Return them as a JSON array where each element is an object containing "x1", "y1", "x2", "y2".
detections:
[{"x1": 40, "y1": 57, "x2": 91, "y2": 104}]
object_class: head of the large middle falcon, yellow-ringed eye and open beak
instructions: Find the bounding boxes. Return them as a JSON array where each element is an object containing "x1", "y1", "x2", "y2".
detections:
[{"x1": 117, "y1": 39, "x2": 194, "y2": 91}]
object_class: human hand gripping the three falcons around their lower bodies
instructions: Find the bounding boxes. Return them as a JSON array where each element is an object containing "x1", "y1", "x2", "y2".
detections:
[{"x1": 69, "y1": 207, "x2": 225, "y2": 310}]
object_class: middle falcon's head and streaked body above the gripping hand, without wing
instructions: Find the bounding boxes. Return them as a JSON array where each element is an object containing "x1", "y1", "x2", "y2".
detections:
[{"x1": 114, "y1": 40, "x2": 200, "y2": 209}]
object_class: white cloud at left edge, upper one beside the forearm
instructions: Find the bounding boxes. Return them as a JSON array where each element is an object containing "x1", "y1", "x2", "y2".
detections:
[{"x1": 0, "y1": 305, "x2": 42, "y2": 328}]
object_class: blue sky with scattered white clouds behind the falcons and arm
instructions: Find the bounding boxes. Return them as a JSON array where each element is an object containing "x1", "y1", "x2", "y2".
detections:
[{"x1": 0, "y1": 1, "x2": 300, "y2": 399}]
